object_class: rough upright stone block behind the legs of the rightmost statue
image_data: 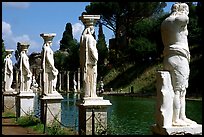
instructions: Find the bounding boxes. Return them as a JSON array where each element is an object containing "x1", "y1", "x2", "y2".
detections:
[{"x1": 156, "y1": 71, "x2": 174, "y2": 127}]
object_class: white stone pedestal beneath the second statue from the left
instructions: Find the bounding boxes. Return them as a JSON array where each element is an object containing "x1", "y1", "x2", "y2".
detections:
[{"x1": 17, "y1": 91, "x2": 35, "y2": 117}]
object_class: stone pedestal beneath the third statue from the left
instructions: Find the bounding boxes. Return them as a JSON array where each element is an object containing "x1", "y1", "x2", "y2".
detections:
[{"x1": 40, "y1": 91, "x2": 63, "y2": 126}]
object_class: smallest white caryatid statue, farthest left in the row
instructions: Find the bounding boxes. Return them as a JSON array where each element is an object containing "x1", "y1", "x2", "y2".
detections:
[{"x1": 4, "y1": 50, "x2": 14, "y2": 91}]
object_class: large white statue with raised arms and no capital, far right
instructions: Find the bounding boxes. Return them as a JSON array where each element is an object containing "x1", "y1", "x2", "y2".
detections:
[{"x1": 161, "y1": 3, "x2": 196, "y2": 126}]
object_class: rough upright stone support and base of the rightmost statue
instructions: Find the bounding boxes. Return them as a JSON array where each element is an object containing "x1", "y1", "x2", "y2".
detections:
[{"x1": 151, "y1": 71, "x2": 202, "y2": 135}]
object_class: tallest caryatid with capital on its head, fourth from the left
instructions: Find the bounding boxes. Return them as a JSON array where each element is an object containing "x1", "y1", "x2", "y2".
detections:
[{"x1": 79, "y1": 15, "x2": 100, "y2": 98}]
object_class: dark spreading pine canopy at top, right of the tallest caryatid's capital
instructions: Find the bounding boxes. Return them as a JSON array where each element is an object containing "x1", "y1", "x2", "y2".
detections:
[{"x1": 85, "y1": 2, "x2": 166, "y2": 46}]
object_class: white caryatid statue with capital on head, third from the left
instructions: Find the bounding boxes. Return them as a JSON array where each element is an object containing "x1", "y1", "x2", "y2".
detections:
[{"x1": 40, "y1": 33, "x2": 58, "y2": 95}]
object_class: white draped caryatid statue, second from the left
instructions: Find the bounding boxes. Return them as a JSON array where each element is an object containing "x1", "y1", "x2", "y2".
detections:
[{"x1": 18, "y1": 42, "x2": 32, "y2": 92}]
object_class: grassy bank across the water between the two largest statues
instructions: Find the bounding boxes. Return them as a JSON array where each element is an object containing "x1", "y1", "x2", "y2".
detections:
[{"x1": 104, "y1": 58, "x2": 162, "y2": 93}]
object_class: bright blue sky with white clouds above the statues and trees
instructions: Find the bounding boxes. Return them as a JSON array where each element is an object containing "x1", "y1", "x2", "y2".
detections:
[{"x1": 2, "y1": 2, "x2": 174, "y2": 63}]
